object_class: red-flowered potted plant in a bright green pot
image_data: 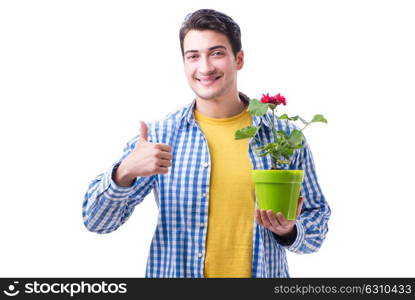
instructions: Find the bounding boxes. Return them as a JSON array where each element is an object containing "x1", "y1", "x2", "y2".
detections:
[{"x1": 235, "y1": 94, "x2": 327, "y2": 220}]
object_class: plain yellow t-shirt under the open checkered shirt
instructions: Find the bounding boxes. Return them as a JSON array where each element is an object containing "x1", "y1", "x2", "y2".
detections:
[{"x1": 195, "y1": 108, "x2": 255, "y2": 278}]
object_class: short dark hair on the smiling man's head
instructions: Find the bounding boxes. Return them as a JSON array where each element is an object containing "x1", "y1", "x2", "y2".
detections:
[{"x1": 179, "y1": 9, "x2": 242, "y2": 57}]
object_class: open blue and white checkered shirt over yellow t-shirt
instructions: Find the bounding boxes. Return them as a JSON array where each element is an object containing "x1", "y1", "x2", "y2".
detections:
[{"x1": 82, "y1": 94, "x2": 330, "y2": 278}]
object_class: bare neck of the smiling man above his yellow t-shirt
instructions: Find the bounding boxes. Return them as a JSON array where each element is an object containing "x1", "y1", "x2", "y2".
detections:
[{"x1": 195, "y1": 92, "x2": 247, "y2": 119}]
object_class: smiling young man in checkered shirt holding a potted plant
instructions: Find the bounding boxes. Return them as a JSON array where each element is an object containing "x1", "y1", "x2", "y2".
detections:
[{"x1": 83, "y1": 9, "x2": 330, "y2": 277}]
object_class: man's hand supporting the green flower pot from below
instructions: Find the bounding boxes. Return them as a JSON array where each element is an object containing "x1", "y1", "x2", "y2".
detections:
[{"x1": 255, "y1": 196, "x2": 304, "y2": 238}]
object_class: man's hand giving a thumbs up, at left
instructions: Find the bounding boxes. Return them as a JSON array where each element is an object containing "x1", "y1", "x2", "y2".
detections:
[{"x1": 113, "y1": 121, "x2": 173, "y2": 187}]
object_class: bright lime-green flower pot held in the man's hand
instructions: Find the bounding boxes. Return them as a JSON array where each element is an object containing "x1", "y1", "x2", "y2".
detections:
[{"x1": 252, "y1": 170, "x2": 304, "y2": 220}]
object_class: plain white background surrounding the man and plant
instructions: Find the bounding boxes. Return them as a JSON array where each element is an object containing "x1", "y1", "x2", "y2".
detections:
[{"x1": 0, "y1": 0, "x2": 415, "y2": 277}]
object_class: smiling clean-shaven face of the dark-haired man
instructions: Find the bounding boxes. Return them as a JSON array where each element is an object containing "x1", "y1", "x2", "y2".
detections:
[{"x1": 183, "y1": 30, "x2": 244, "y2": 100}]
